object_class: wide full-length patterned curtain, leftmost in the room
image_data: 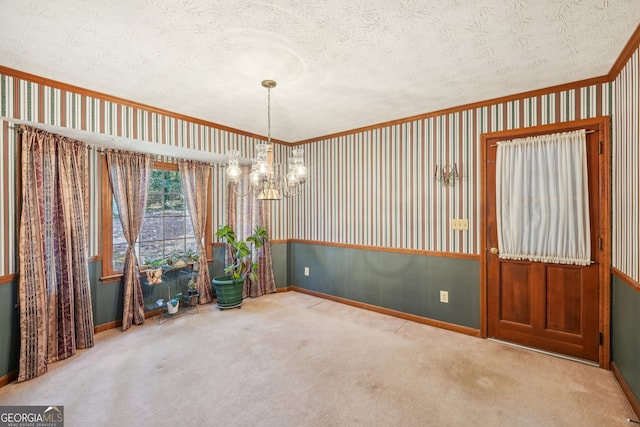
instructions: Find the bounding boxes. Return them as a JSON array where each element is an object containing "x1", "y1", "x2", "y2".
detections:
[{"x1": 18, "y1": 126, "x2": 94, "y2": 381}]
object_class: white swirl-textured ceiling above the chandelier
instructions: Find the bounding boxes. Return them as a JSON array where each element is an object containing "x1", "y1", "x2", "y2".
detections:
[{"x1": 0, "y1": 0, "x2": 640, "y2": 142}]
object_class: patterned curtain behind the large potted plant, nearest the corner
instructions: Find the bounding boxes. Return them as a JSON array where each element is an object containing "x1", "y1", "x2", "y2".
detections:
[{"x1": 226, "y1": 167, "x2": 276, "y2": 297}]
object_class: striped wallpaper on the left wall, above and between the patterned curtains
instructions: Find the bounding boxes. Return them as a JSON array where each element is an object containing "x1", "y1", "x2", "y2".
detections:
[{"x1": 0, "y1": 74, "x2": 287, "y2": 276}]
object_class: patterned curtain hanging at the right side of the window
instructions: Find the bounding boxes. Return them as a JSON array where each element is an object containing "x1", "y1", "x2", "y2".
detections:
[{"x1": 178, "y1": 160, "x2": 213, "y2": 304}]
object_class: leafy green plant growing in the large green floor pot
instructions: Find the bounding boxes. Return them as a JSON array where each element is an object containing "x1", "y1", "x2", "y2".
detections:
[{"x1": 216, "y1": 225, "x2": 267, "y2": 281}]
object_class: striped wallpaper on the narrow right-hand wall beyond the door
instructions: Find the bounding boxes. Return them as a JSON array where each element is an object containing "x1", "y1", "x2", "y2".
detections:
[{"x1": 611, "y1": 49, "x2": 640, "y2": 282}]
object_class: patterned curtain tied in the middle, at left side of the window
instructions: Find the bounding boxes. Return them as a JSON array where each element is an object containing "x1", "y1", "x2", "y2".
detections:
[{"x1": 106, "y1": 151, "x2": 153, "y2": 331}]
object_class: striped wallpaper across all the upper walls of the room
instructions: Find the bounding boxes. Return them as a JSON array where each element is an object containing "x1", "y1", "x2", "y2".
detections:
[{"x1": 0, "y1": 61, "x2": 640, "y2": 280}]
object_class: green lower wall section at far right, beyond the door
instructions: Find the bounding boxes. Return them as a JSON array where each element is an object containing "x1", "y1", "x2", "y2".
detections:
[{"x1": 611, "y1": 276, "x2": 640, "y2": 406}]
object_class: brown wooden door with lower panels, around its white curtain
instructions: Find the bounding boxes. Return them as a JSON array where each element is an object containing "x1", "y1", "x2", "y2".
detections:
[{"x1": 485, "y1": 126, "x2": 602, "y2": 362}]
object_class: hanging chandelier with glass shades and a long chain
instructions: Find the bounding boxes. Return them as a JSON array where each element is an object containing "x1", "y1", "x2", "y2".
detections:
[{"x1": 227, "y1": 80, "x2": 307, "y2": 200}]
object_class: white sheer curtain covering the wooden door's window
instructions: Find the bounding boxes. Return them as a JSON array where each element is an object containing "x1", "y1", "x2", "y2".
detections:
[{"x1": 496, "y1": 129, "x2": 591, "y2": 265}]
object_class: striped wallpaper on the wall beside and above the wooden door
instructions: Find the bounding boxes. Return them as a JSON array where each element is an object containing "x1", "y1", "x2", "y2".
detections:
[{"x1": 288, "y1": 83, "x2": 611, "y2": 255}]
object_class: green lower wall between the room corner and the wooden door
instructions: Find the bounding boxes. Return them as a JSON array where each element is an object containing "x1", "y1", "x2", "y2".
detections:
[{"x1": 289, "y1": 243, "x2": 480, "y2": 329}]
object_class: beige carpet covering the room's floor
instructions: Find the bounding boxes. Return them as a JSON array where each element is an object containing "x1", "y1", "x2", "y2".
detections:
[{"x1": 0, "y1": 292, "x2": 633, "y2": 426}]
